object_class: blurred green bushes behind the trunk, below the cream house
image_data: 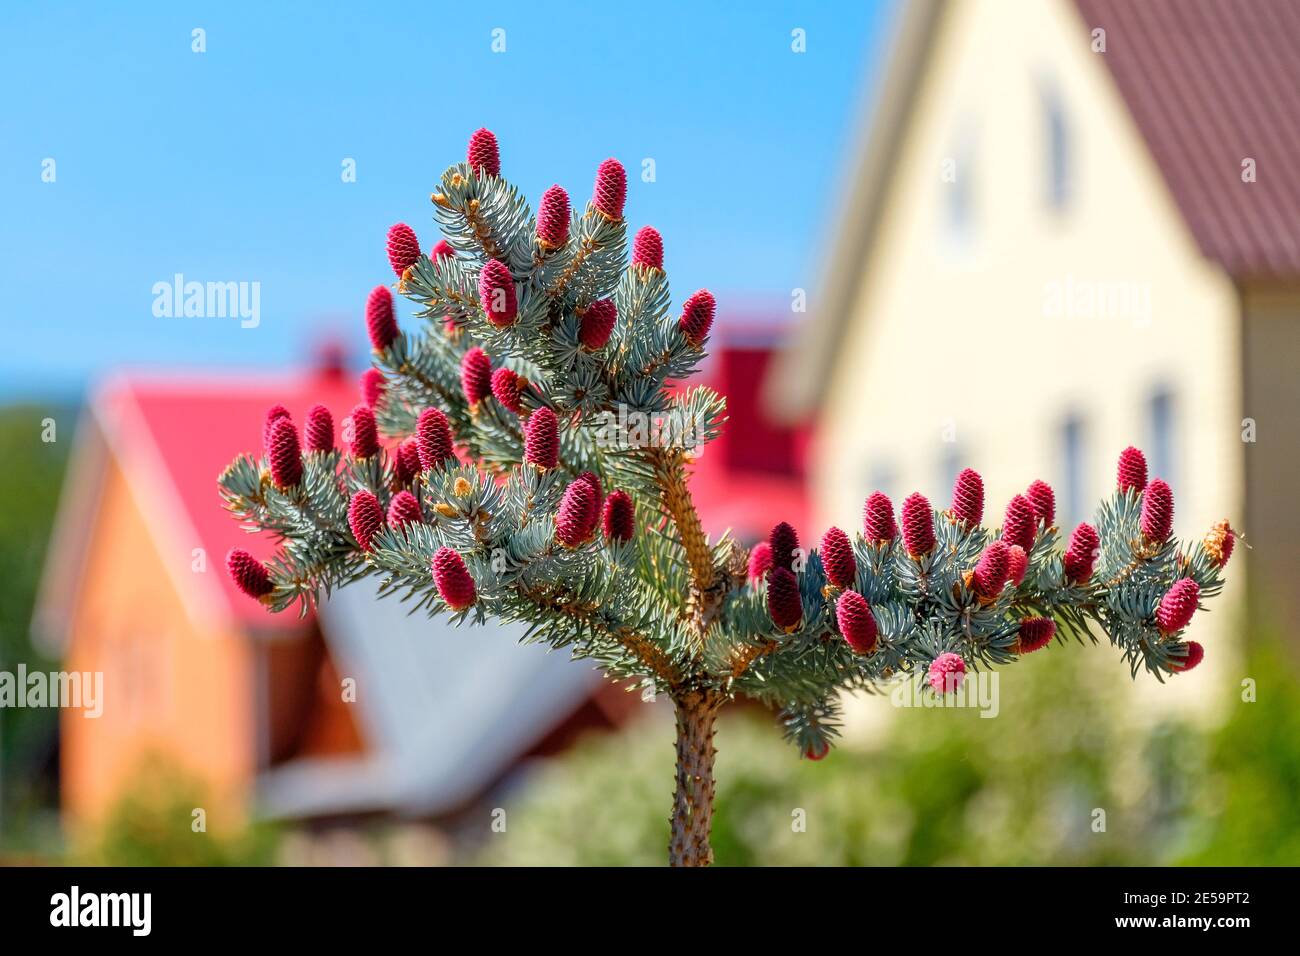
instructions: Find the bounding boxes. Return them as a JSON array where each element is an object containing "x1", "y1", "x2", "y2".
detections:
[{"x1": 475, "y1": 639, "x2": 1300, "y2": 866}]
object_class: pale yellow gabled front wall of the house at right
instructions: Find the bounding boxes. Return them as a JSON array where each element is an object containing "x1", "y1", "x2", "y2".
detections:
[{"x1": 811, "y1": 0, "x2": 1244, "y2": 711}]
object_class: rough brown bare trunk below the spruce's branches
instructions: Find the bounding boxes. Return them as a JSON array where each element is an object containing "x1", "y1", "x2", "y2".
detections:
[{"x1": 668, "y1": 691, "x2": 722, "y2": 866}]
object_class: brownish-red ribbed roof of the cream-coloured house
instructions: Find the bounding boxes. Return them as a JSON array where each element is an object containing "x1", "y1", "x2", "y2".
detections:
[{"x1": 1075, "y1": 0, "x2": 1300, "y2": 278}]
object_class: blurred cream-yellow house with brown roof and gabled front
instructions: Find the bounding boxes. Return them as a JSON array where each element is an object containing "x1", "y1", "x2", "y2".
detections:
[{"x1": 767, "y1": 0, "x2": 1300, "y2": 695}]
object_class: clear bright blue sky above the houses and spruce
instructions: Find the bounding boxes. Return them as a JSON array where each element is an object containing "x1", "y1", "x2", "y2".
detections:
[{"x1": 0, "y1": 0, "x2": 893, "y2": 398}]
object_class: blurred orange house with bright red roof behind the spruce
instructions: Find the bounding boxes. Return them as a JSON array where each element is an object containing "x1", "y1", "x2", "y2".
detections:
[{"x1": 34, "y1": 330, "x2": 802, "y2": 827}]
